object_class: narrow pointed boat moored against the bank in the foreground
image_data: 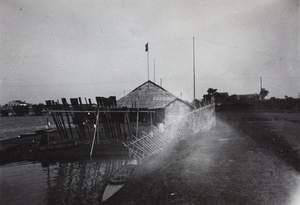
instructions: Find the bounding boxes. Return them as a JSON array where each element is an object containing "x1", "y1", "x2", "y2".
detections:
[{"x1": 102, "y1": 160, "x2": 137, "y2": 202}]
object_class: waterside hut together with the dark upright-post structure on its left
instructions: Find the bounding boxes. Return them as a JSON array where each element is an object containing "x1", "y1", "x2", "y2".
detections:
[{"x1": 39, "y1": 81, "x2": 194, "y2": 155}]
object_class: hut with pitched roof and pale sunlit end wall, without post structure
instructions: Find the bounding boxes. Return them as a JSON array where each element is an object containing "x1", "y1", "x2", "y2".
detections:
[{"x1": 117, "y1": 80, "x2": 194, "y2": 123}]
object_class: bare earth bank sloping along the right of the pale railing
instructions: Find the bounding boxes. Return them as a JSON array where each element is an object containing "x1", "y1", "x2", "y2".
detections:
[{"x1": 105, "y1": 114, "x2": 300, "y2": 204}]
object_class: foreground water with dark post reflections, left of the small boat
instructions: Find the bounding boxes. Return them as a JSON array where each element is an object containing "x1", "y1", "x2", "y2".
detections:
[{"x1": 0, "y1": 157, "x2": 128, "y2": 204}]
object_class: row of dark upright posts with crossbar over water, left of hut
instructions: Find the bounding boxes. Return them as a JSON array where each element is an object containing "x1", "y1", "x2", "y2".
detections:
[{"x1": 46, "y1": 97, "x2": 156, "y2": 144}]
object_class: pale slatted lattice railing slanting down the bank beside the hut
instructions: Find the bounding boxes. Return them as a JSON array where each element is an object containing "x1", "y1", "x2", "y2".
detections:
[{"x1": 124, "y1": 104, "x2": 216, "y2": 159}]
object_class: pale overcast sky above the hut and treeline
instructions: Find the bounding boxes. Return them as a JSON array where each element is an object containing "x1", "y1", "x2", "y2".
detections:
[{"x1": 0, "y1": 0, "x2": 300, "y2": 105}]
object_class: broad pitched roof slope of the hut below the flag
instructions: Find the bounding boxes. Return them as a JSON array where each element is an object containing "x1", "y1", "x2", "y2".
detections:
[{"x1": 117, "y1": 80, "x2": 177, "y2": 108}]
